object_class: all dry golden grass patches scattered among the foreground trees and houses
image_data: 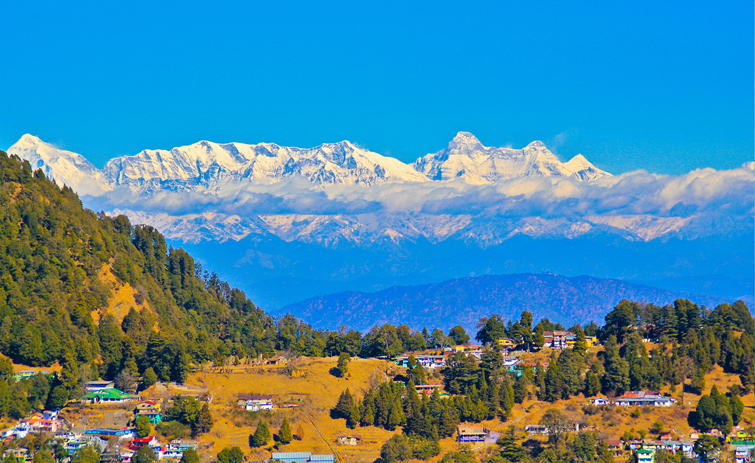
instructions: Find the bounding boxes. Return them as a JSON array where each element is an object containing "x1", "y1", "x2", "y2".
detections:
[{"x1": 3, "y1": 344, "x2": 755, "y2": 463}]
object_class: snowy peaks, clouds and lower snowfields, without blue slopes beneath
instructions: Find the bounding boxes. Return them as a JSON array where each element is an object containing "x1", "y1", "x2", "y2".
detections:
[{"x1": 8, "y1": 132, "x2": 753, "y2": 247}]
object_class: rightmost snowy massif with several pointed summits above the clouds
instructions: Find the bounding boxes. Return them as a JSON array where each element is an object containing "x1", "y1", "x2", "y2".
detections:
[{"x1": 413, "y1": 132, "x2": 610, "y2": 183}]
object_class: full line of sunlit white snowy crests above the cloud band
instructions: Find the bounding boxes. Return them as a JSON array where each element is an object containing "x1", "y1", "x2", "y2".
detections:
[{"x1": 8, "y1": 132, "x2": 610, "y2": 196}]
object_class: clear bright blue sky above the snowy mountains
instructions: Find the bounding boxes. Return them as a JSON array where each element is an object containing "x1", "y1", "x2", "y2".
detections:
[{"x1": 0, "y1": 1, "x2": 753, "y2": 174}]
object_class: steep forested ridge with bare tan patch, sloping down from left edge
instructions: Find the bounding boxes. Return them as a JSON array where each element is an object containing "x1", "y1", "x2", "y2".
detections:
[{"x1": 0, "y1": 152, "x2": 286, "y2": 386}]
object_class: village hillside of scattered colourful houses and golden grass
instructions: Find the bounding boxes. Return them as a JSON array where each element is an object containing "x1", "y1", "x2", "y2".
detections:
[{"x1": 0, "y1": 320, "x2": 755, "y2": 463}]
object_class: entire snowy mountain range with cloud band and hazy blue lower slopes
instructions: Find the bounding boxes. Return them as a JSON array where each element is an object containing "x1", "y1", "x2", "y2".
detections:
[{"x1": 7, "y1": 132, "x2": 755, "y2": 307}]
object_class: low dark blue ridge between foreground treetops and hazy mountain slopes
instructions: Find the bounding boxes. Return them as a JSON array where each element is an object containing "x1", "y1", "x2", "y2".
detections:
[{"x1": 277, "y1": 273, "x2": 735, "y2": 333}]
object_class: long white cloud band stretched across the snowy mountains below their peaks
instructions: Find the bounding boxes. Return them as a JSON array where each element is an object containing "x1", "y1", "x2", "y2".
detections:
[{"x1": 90, "y1": 167, "x2": 755, "y2": 218}]
